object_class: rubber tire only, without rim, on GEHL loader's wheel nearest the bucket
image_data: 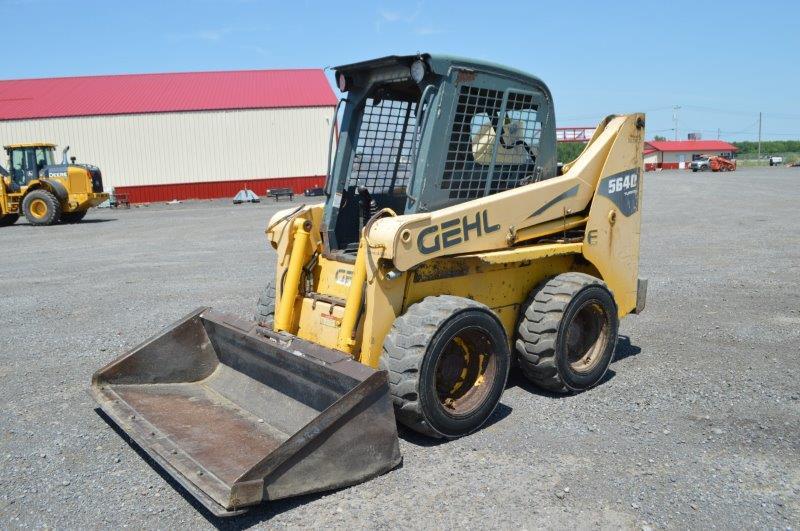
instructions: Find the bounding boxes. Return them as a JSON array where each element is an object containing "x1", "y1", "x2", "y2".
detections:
[{"x1": 380, "y1": 295, "x2": 511, "y2": 438}]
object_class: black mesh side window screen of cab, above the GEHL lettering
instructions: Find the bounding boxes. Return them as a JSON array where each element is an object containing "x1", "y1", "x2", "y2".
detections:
[{"x1": 442, "y1": 85, "x2": 541, "y2": 199}]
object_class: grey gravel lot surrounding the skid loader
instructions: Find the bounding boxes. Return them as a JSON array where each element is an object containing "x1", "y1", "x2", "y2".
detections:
[{"x1": 0, "y1": 168, "x2": 800, "y2": 529}]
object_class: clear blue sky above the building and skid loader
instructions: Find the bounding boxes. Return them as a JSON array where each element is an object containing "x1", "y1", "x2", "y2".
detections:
[{"x1": 0, "y1": 0, "x2": 800, "y2": 140}]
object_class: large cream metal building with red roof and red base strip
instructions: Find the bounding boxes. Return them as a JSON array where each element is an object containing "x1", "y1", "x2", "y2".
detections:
[{"x1": 0, "y1": 69, "x2": 336, "y2": 202}]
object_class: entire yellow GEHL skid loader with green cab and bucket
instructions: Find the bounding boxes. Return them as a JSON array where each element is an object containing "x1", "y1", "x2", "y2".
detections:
[{"x1": 92, "y1": 54, "x2": 647, "y2": 515}]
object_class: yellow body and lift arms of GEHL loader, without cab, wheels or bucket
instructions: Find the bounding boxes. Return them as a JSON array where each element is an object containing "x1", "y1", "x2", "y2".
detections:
[{"x1": 267, "y1": 114, "x2": 644, "y2": 368}]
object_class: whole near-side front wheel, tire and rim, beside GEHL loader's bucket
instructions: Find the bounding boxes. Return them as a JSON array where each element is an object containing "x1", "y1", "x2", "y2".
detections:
[{"x1": 381, "y1": 295, "x2": 511, "y2": 438}]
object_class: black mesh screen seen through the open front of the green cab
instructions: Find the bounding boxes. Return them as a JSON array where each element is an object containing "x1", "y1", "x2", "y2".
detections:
[{"x1": 348, "y1": 98, "x2": 417, "y2": 194}]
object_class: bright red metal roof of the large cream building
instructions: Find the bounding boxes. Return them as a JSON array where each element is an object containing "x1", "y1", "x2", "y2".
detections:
[{"x1": 0, "y1": 69, "x2": 336, "y2": 120}]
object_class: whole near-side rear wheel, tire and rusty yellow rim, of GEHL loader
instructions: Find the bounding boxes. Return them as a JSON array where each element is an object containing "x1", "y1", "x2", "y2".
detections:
[{"x1": 515, "y1": 273, "x2": 619, "y2": 392}]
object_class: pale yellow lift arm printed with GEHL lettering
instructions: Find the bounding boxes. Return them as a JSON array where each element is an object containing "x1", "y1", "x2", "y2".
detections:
[{"x1": 367, "y1": 114, "x2": 644, "y2": 271}]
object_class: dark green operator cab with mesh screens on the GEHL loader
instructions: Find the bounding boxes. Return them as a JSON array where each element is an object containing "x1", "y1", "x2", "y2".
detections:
[{"x1": 324, "y1": 54, "x2": 556, "y2": 255}]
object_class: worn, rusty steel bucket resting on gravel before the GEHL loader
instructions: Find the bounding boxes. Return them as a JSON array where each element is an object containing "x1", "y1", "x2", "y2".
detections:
[{"x1": 91, "y1": 308, "x2": 401, "y2": 516}]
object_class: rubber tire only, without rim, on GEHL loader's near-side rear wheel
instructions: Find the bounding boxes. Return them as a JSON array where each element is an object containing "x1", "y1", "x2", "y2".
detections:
[{"x1": 515, "y1": 273, "x2": 619, "y2": 392}]
